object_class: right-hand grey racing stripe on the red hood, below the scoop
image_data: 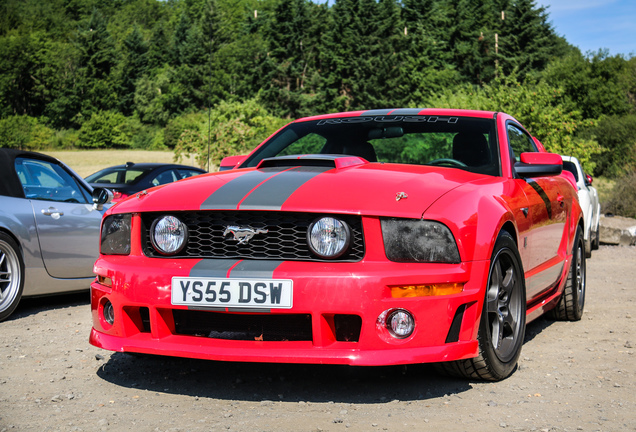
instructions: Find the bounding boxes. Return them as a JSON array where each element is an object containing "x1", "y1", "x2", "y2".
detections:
[{"x1": 239, "y1": 166, "x2": 332, "y2": 210}]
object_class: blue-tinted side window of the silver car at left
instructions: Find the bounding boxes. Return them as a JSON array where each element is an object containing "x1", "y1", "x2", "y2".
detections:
[{"x1": 15, "y1": 158, "x2": 88, "y2": 204}]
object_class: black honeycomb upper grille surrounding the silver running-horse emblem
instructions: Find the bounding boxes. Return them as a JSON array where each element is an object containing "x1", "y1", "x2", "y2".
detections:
[{"x1": 141, "y1": 211, "x2": 364, "y2": 262}]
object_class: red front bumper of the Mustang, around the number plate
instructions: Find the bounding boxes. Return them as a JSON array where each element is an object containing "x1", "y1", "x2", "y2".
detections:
[{"x1": 90, "y1": 256, "x2": 489, "y2": 366}]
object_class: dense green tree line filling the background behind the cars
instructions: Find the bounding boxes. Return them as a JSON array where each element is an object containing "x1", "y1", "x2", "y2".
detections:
[{"x1": 0, "y1": 0, "x2": 636, "y2": 176}]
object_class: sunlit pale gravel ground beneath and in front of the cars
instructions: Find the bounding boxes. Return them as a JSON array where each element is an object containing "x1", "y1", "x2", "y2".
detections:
[{"x1": 0, "y1": 246, "x2": 636, "y2": 431}]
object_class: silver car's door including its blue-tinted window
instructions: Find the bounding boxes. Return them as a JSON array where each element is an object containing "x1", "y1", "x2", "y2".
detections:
[{"x1": 15, "y1": 157, "x2": 103, "y2": 279}]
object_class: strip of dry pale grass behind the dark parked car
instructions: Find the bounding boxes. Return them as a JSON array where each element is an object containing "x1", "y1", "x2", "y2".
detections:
[{"x1": 42, "y1": 150, "x2": 197, "y2": 177}]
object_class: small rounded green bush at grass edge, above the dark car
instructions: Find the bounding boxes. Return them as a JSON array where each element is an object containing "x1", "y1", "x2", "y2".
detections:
[{"x1": 78, "y1": 111, "x2": 133, "y2": 149}]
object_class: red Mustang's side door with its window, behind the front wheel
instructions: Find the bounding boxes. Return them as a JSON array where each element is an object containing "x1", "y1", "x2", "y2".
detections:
[{"x1": 506, "y1": 122, "x2": 567, "y2": 301}]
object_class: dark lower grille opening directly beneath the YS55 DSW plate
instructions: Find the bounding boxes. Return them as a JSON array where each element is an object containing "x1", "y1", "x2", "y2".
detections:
[{"x1": 172, "y1": 309, "x2": 312, "y2": 342}]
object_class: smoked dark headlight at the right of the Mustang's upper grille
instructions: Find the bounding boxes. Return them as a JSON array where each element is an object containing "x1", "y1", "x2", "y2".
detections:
[{"x1": 382, "y1": 218, "x2": 460, "y2": 263}]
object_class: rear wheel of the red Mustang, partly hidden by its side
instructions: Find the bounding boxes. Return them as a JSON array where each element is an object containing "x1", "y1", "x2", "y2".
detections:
[{"x1": 552, "y1": 227, "x2": 587, "y2": 321}]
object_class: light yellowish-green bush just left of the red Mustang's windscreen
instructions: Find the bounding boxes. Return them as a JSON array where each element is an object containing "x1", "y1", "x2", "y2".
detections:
[{"x1": 175, "y1": 99, "x2": 286, "y2": 168}]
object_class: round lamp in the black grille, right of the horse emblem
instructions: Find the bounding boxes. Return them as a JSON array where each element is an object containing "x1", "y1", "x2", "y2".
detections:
[{"x1": 307, "y1": 217, "x2": 351, "y2": 258}]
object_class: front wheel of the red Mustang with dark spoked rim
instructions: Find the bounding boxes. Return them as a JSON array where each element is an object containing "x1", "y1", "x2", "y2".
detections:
[{"x1": 440, "y1": 232, "x2": 526, "y2": 381}]
